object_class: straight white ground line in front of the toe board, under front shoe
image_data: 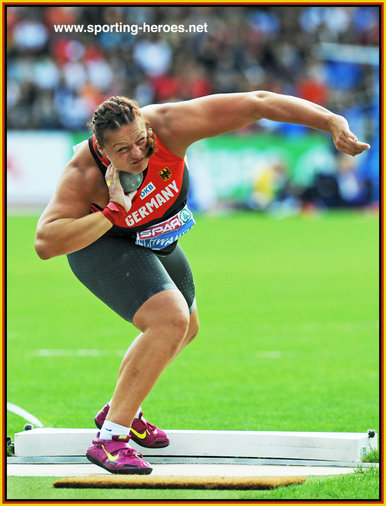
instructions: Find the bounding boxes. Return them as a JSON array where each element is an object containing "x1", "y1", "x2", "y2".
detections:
[{"x1": 7, "y1": 464, "x2": 355, "y2": 477}]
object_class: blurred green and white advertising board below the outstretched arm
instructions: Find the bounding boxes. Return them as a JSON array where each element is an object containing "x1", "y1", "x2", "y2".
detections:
[{"x1": 188, "y1": 133, "x2": 335, "y2": 210}]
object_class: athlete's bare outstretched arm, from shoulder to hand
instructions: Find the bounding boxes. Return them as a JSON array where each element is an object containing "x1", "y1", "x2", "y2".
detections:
[{"x1": 144, "y1": 91, "x2": 370, "y2": 156}]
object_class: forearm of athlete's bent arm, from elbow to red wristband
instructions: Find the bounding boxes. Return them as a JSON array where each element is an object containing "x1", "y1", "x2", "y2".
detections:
[{"x1": 35, "y1": 212, "x2": 112, "y2": 260}]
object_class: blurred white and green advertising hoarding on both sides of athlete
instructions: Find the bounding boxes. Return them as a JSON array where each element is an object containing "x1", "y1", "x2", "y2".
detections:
[{"x1": 7, "y1": 131, "x2": 334, "y2": 211}]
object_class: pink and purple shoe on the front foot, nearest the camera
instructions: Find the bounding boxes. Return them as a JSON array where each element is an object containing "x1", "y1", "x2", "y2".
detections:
[{"x1": 86, "y1": 432, "x2": 153, "y2": 474}]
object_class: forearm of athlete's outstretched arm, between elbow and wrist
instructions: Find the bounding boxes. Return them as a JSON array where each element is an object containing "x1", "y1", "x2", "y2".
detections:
[{"x1": 255, "y1": 91, "x2": 337, "y2": 132}]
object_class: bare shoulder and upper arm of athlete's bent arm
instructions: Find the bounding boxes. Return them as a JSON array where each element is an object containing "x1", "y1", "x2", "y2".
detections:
[{"x1": 41, "y1": 142, "x2": 108, "y2": 222}]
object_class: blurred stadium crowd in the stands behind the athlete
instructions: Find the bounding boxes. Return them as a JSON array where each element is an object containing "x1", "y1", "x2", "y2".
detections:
[{"x1": 6, "y1": 5, "x2": 379, "y2": 206}]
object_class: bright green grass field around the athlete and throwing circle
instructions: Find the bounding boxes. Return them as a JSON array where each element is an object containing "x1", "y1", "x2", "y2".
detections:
[{"x1": 7, "y1": 213, "x2": 379, "y2": 499}]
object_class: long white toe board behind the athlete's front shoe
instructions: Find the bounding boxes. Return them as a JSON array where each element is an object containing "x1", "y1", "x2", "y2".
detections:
[{"x1": 15, "y1": 428, "x2": 377, "y2": 462}]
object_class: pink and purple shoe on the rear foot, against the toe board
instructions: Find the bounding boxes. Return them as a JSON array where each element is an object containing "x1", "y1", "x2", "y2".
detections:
[{"x1": 95, "y1": 404, "x2": 170, "y2": 448}]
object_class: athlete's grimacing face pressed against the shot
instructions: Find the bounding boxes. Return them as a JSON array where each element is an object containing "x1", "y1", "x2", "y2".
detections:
[{"x1": 101, "y1": 118, "x2": 149, "y2": 174}]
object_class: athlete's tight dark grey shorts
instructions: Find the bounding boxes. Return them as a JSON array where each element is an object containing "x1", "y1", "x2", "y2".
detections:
[{"x1": 67, "y1": 235, "x2": 195, "y2": 322}]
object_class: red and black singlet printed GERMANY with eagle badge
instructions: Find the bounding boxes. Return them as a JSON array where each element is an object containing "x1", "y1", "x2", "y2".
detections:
[{"x1": 88, "y1": 135, "x2": 189, "y2": 244}]
